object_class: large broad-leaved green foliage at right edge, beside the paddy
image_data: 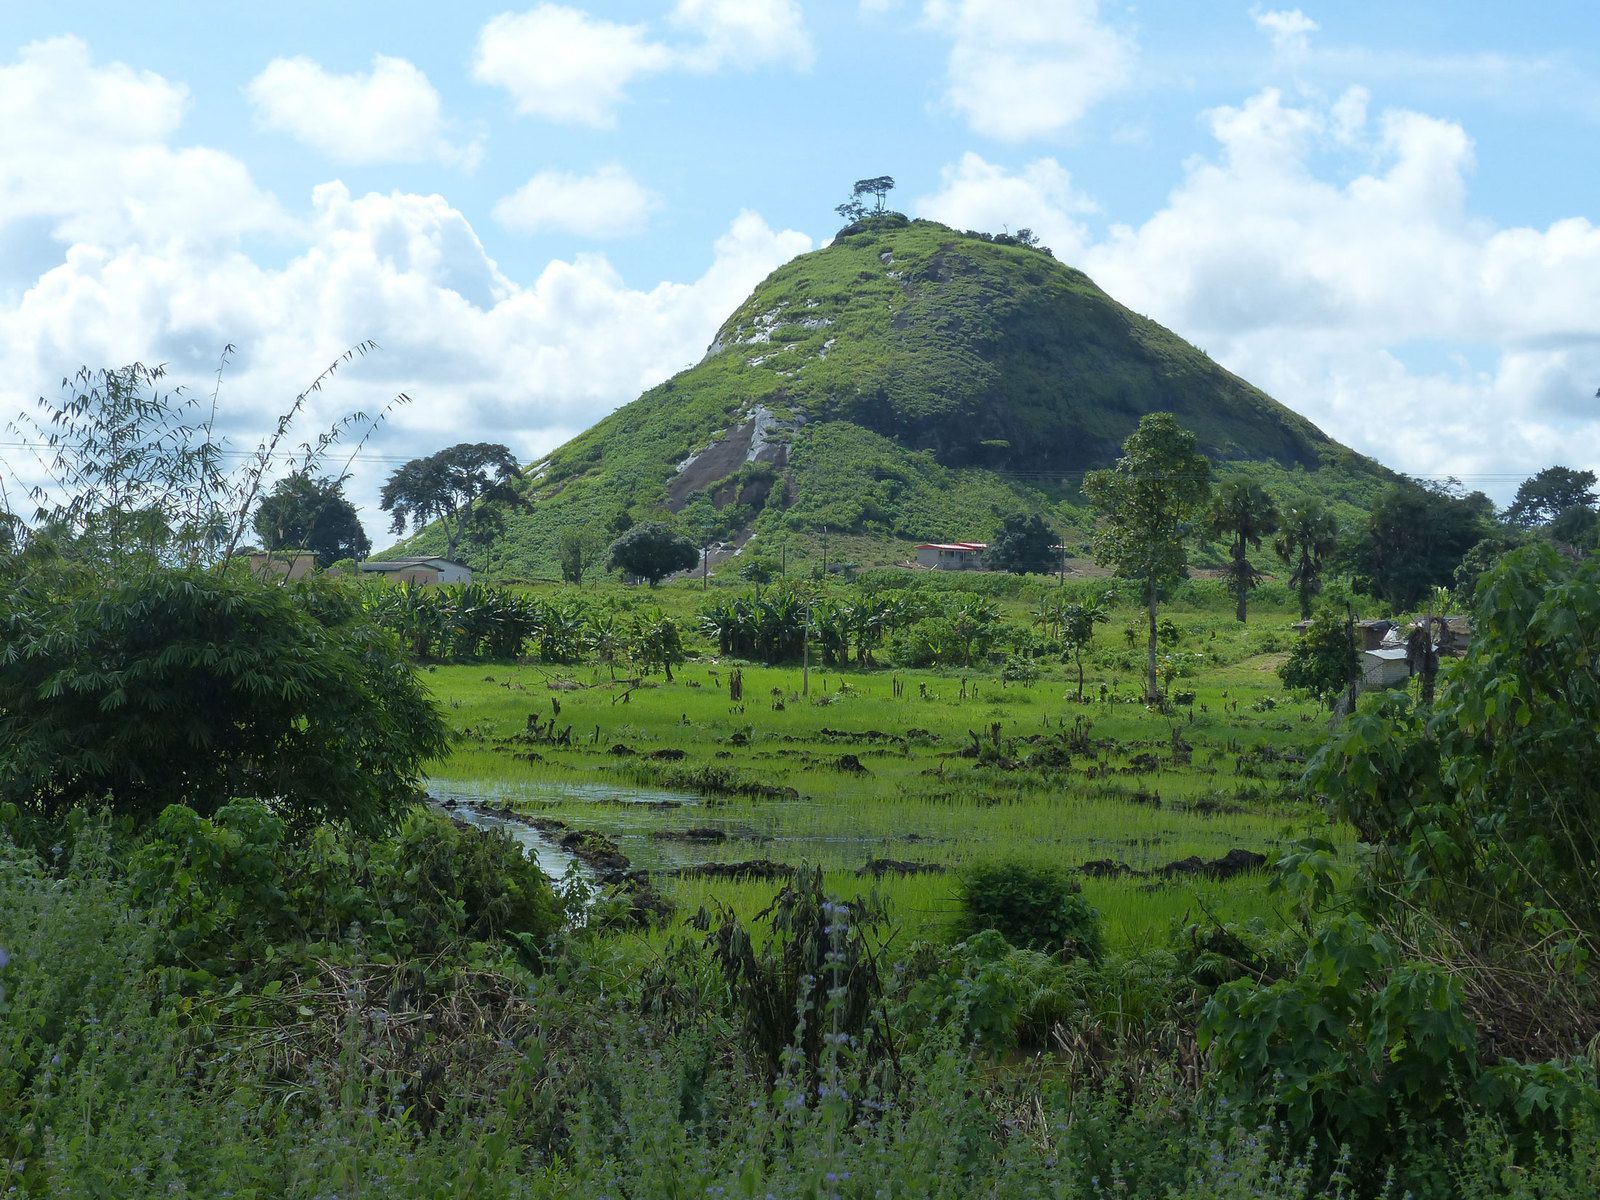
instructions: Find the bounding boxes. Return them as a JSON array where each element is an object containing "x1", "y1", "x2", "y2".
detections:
[{"x1": 1309, "y1": 544, "x2": 1600, "y2": 940}]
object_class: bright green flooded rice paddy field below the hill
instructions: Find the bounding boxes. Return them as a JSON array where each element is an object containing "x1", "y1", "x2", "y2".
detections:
[{"x1": 422, "y1": 587, "x2": 1347, "y2": 947}]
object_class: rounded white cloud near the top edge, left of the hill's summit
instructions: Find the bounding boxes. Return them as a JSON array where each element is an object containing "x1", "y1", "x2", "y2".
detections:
[{"x1": 472, "y1": 5, "x2": 672, "y2": 128}]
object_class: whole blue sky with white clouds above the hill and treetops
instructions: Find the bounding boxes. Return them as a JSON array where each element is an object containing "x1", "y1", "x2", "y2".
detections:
[{"x1": 0, "y1": 0, "x2": 1600, "y2": 534}]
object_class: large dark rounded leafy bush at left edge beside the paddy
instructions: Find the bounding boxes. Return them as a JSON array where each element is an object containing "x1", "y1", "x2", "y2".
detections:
[{"x1": 0, "y1": 570, "x2": 446, "y2": 829}]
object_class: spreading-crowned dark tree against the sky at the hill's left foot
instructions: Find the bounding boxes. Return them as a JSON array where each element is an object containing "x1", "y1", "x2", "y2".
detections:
[{"x1": 382, "y1": 442, "x2": 517, "y2": 558}]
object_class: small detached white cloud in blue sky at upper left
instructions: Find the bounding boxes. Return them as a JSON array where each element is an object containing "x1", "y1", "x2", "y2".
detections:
[{"x1": 246, "y1": 54, "x2": 482, "y2": 168}]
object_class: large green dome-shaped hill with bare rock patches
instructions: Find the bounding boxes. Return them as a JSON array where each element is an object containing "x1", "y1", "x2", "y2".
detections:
[{"x1": 395, "y1": 214, "x2": 1389, "y2": 576}]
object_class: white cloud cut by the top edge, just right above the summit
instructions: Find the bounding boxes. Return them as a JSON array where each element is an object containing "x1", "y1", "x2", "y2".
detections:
[{"x1": 923, "y1": 0, "x2": 1134, "y2": 141}]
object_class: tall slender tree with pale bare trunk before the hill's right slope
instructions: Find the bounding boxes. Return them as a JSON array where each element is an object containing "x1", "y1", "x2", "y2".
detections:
[{"x1": 1083, "y1": 413, "x2": 1211, "y2": 704}]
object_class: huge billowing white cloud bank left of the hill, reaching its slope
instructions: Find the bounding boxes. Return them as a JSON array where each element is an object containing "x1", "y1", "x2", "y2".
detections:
[{"x1": 0, "y1": 38, "x2": 811, "y2": 534}]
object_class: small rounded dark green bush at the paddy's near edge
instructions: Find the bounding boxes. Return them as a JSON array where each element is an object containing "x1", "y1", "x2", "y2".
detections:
[{"x1": 955, "y1": 862, "x2": 1102, "y2": 962}]
